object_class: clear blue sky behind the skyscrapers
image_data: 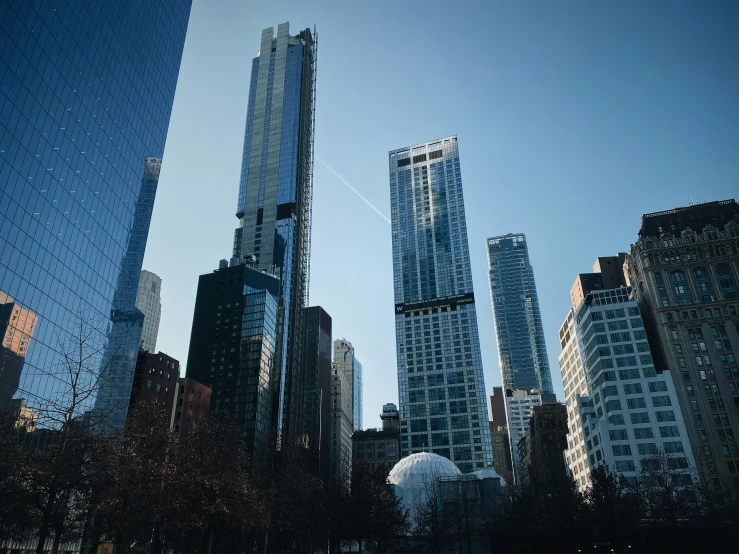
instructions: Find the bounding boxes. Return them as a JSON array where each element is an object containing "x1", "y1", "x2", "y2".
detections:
[{"x1": 144, "y1": 0, "x2": 739, "y2": 427}]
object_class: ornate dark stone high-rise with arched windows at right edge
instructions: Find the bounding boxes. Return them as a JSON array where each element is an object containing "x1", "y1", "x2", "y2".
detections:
[{"x1": 627, "y1": 200, "x2": 739, "y2": 488}]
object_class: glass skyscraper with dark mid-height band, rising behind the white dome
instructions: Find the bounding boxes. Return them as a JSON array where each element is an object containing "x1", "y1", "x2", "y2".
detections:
[{"x1": 389, "y1": 136, "x2": 492, "y2": 472}]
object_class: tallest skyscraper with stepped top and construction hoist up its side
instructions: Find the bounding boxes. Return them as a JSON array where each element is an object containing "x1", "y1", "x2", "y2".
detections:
[{"x1": 233, "y1": 23, "x2": 316, "y2": 443}]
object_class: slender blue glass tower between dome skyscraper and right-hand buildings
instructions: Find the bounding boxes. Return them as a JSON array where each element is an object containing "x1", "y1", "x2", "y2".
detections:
[{"x1": 487, "y1": 233, "x2": 553, "y2": 393}]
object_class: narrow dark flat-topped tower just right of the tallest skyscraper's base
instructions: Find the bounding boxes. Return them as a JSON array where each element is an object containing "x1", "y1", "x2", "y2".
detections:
[{"x1": 303, "y1": 306, "x2": 333, "y2": 480}]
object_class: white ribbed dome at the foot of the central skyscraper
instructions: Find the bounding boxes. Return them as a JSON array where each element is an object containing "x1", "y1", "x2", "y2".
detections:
[{"x1": 388, "y1": 452, "x2": 462, "y2": 511}]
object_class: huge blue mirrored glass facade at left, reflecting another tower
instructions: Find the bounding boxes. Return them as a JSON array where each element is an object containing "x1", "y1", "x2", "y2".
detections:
[{"x1": 0, "y1": 0, "x2": 191, "y2": 425}]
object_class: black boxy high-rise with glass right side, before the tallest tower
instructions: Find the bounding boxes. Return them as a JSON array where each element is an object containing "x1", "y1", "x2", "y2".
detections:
[{"x1": 187, "y1": 258, "x2": 280, "y2": 455}]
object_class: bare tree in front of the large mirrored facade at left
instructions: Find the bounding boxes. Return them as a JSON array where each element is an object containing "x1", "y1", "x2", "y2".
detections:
[{"x1": 19, "y1": 312, "x2": 121, "y2": 554}]
